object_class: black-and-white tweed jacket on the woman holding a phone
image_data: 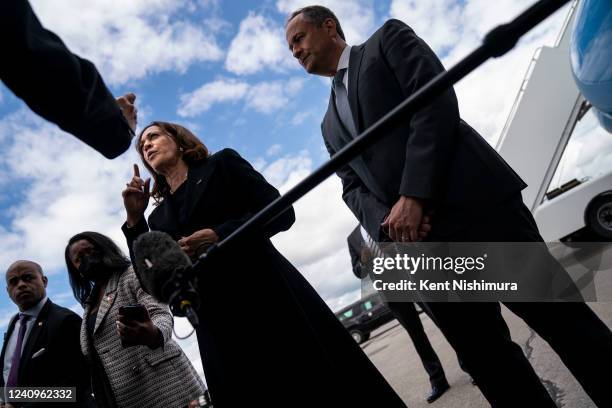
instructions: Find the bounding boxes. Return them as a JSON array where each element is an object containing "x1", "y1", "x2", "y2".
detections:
[{"x1": 80, "y1": 267, "x2": 205, "y2": 408}]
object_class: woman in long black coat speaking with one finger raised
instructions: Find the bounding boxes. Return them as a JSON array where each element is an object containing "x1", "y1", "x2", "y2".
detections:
[{"x1": 123, "y1": 122, "x2": 404, "y2": 408}]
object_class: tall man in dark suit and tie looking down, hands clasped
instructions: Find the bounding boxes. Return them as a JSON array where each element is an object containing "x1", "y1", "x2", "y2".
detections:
[{"x1": 286, "y1": 6, "x2": 612, "y2": 407}]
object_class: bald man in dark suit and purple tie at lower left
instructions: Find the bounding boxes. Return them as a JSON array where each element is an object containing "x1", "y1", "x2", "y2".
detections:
[{"x1": 0, "y1": 261, "x2": 95, "y2": 407}]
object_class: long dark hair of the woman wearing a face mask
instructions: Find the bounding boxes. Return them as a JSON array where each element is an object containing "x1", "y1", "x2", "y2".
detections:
[{"x1": 64, "y1": 231, "x2": 131, "y2": 307}]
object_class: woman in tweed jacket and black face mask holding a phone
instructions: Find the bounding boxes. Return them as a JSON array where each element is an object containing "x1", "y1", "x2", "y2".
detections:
[{"x1": 65, "y1": 232, "x2": 204, "y2": 408}]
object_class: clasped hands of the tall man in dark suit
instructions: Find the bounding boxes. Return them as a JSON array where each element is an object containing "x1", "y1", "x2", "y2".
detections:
[{"x1": 382, "y1": 196, "x2": 431, "y2": 242}]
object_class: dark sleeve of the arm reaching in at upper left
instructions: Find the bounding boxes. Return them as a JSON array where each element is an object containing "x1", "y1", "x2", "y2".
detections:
[{"x1": 0, "y1": 0, "x2": 132, "y2": 158}]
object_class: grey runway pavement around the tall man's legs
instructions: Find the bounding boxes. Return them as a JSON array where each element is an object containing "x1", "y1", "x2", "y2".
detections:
[{"x1": 362, "y1": 303, "x2": 612, "y2": 408}]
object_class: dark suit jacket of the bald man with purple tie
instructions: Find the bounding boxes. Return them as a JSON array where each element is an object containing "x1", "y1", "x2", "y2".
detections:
[{"x1": 0, "y1": 300, "x2": 94, "y2": 407}]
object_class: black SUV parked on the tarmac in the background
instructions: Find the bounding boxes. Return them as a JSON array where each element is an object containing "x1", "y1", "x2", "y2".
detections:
[{"x1": 336, "y1": 294, "x2": 394, "y2": 343}]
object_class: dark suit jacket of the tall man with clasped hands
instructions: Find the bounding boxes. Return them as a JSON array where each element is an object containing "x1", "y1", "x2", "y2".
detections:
[{"x1": 321, "y1": 20, "x2": 526, "y2": 241}]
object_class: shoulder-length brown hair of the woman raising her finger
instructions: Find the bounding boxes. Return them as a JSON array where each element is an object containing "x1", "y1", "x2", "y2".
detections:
[{"x1": 136, "y1": 121, "x2": 210, "y2": 203}]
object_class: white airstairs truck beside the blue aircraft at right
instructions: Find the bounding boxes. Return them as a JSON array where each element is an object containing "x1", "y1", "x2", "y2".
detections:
[{"x1": 497, "y1": 2, "x2": 612, "y2": 242}]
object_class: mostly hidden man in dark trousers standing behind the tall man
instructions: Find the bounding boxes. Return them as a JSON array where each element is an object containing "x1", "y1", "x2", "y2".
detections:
[{"x1": 346, "y1": 225, "x2": 450, "y2": 403}]
